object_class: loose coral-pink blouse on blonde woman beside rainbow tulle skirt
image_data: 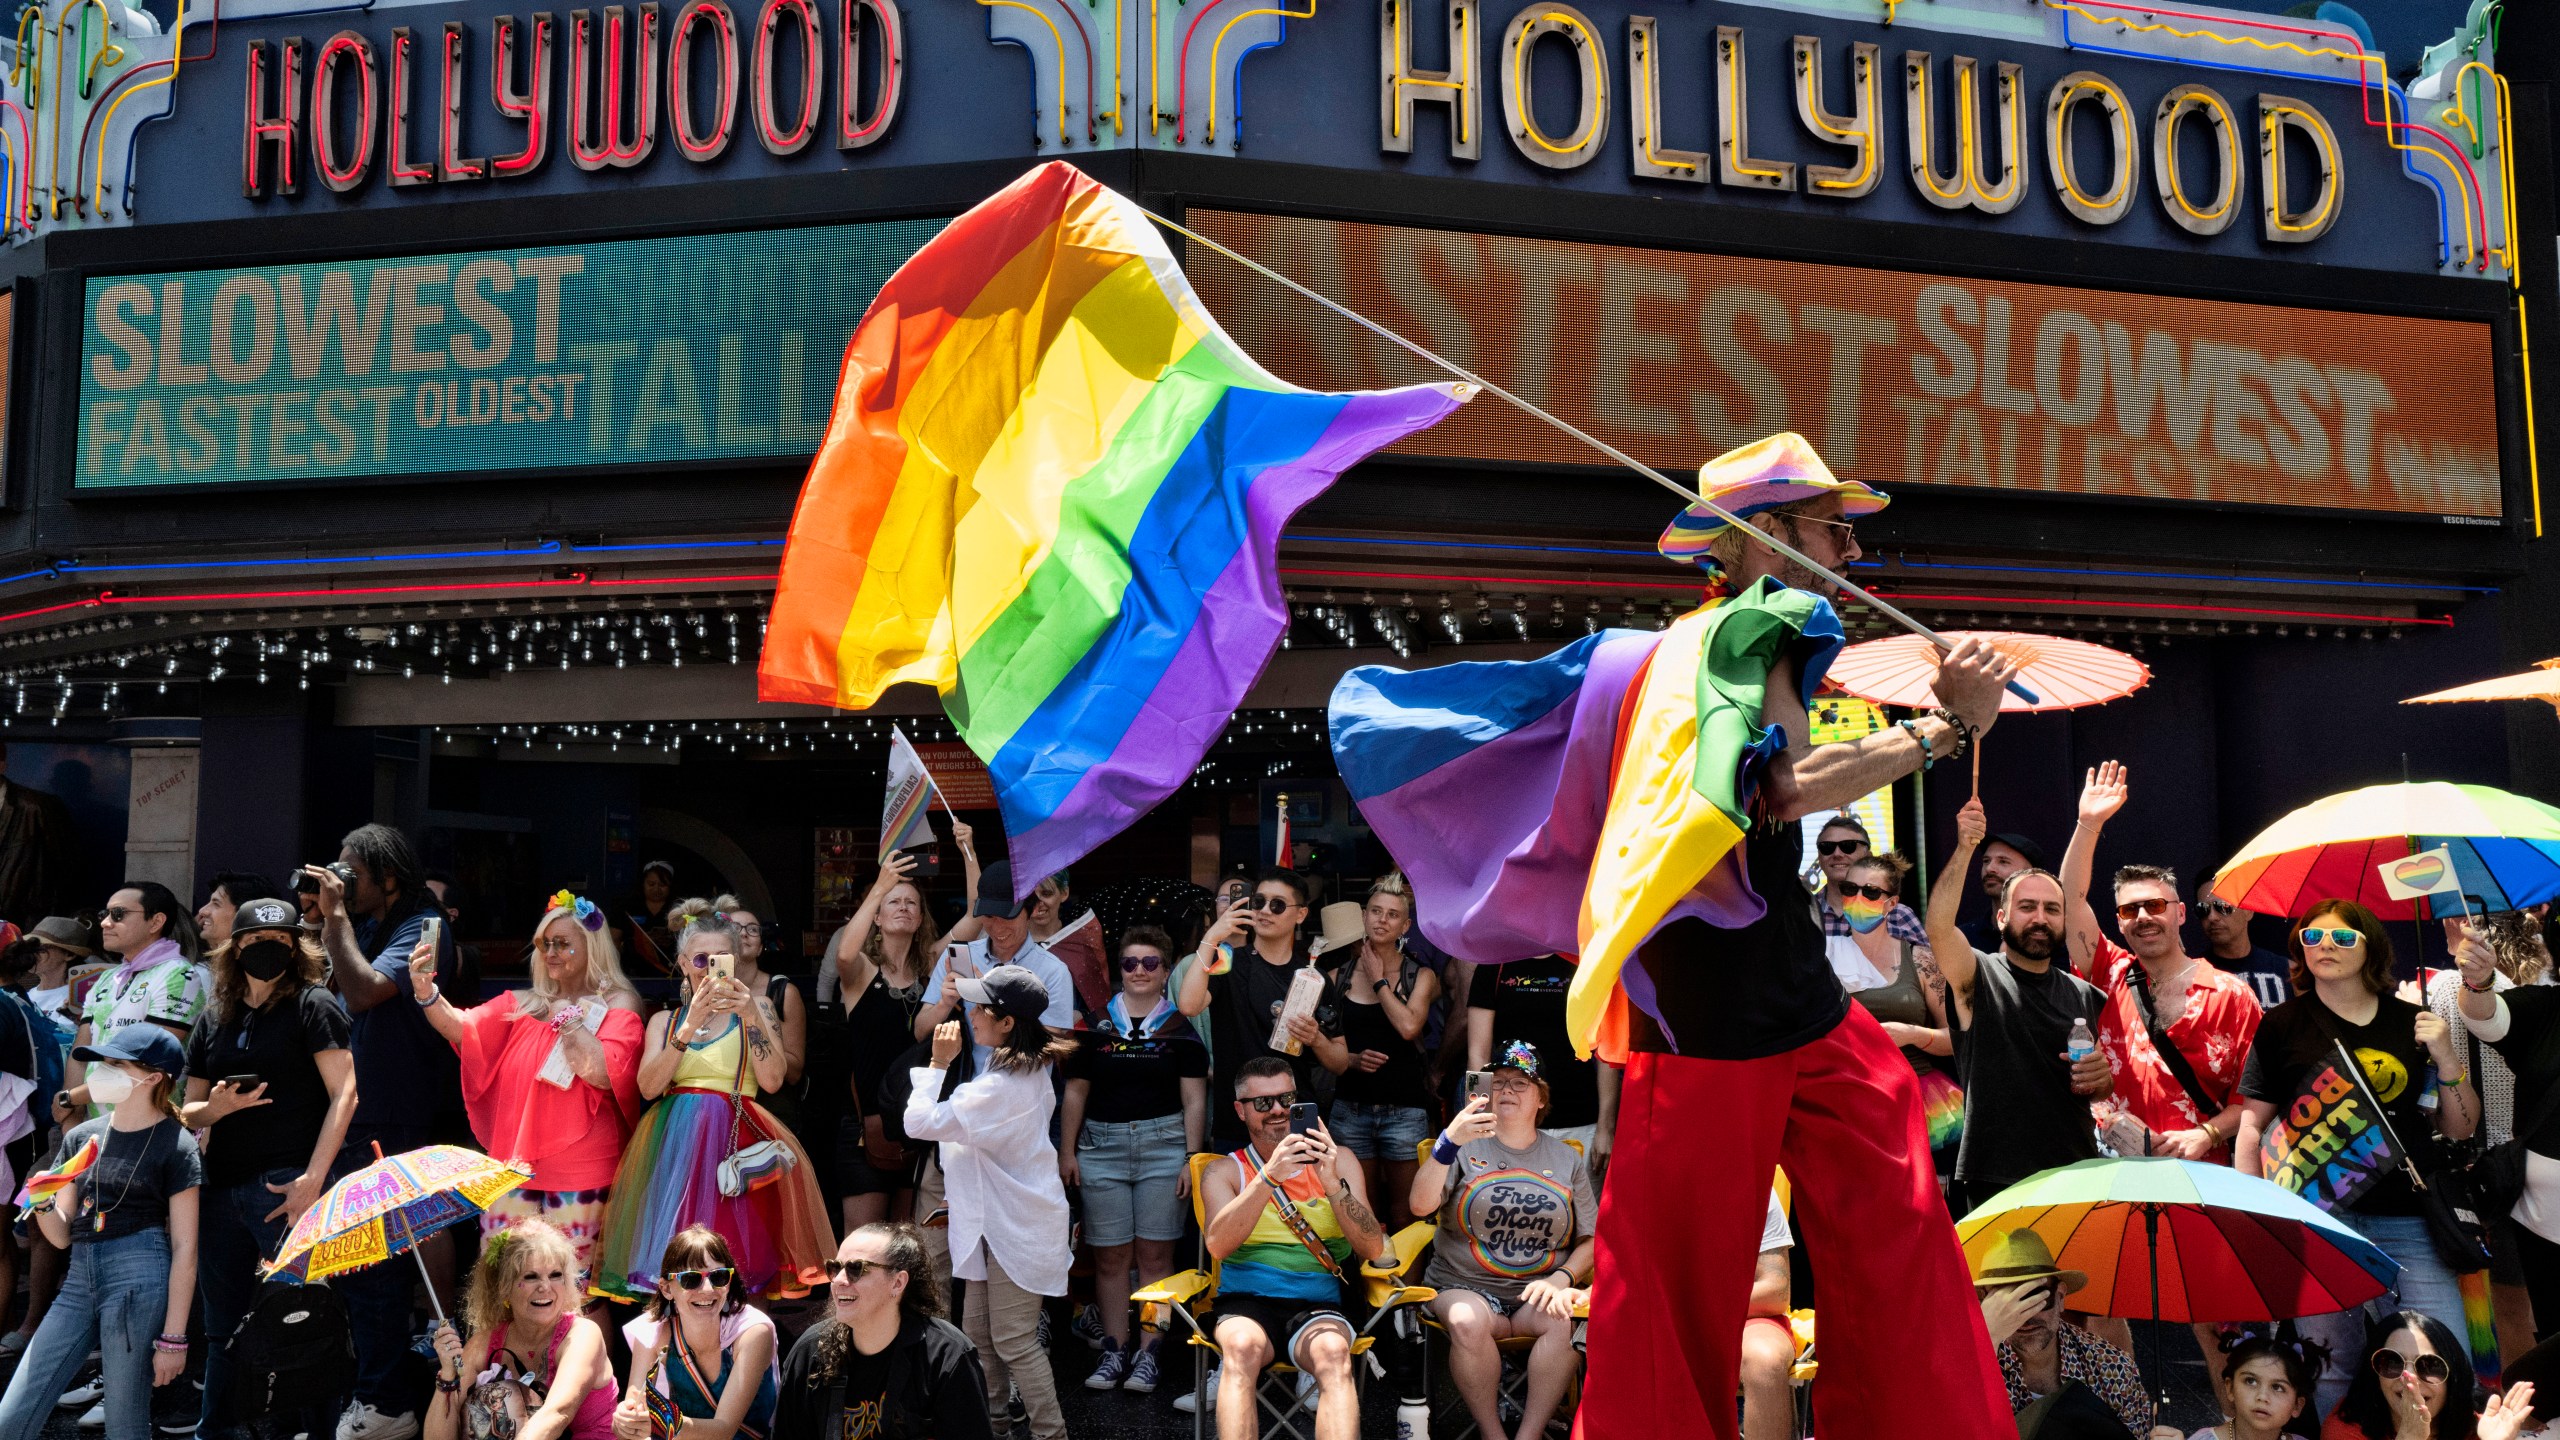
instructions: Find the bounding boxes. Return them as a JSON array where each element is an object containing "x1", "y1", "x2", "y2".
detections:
[{"x1": 453, "y1": 992, "x2": 648, "y2": 1191}]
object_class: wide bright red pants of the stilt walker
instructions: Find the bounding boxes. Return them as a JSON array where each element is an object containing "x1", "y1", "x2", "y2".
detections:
[{"x1": 1577, "y1": 1004, "x2": 2017, "y2": 1440}]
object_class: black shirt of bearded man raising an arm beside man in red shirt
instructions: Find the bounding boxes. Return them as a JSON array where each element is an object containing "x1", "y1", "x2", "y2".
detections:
[{"x1": 1953, "y1": 951, "x2": 2107, "y2": 1186}]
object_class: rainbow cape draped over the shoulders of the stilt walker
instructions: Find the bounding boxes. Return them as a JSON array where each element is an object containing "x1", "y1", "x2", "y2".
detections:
[{"x1": 1331, "y1": 579, "x2": 1843, "y2": 1056}]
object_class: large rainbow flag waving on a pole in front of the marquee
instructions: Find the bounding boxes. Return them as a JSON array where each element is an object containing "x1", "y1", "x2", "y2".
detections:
[{"x1": 758, "y1": 161, "x2": 1467, "y2": 892}]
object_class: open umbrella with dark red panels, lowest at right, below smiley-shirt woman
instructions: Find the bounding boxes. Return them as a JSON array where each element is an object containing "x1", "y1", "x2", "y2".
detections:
[{"x1": 1956, "y1": 1158, "x2": 2399, "y2": 1424}]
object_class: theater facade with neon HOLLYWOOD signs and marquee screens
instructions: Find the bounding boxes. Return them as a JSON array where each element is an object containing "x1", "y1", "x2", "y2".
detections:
[{"x1": 0, "y1": 0, "x2": 2560, "y2": 938}]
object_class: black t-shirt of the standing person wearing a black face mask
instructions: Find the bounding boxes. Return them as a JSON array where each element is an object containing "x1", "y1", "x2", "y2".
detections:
[{"x1": 187, "y1": 986, "x2": 348, "y2": 1186}]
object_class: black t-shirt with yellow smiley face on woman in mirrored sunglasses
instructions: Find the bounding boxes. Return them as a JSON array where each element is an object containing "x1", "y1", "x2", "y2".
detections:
[{"x1": 2240, "y1": 992, "x2": 2437, "y2": 1215}]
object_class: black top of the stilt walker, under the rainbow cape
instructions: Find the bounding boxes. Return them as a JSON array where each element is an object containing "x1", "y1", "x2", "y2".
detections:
[{"x1": 1628, "y1": 820, "x2": 1848, "y2": 1061}]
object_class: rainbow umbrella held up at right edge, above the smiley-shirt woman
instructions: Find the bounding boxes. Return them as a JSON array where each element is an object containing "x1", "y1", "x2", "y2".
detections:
[{"x1": 2214, "y1": 781, "x2": 2560, "y2": 920}]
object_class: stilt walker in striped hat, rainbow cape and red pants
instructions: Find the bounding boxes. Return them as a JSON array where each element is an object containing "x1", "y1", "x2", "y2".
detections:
[{"x1": 1334, "y1": 436, "x2": 2015, "y2": 1440}]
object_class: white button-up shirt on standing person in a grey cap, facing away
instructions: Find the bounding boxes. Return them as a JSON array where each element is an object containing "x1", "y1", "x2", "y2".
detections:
[{"x1": 906, "y1": 1066, "x2": 1068, "y2": 1294}]
